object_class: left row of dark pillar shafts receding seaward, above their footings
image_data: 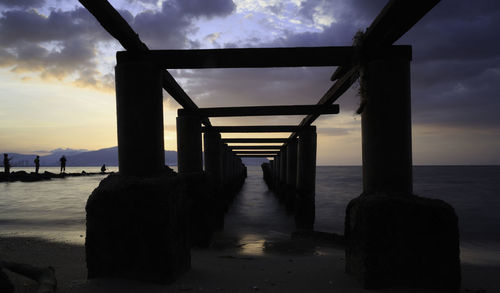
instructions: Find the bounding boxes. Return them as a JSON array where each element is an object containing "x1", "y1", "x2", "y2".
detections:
[{"x1": 115, "y1": 62, "x2": 246, "y2": 188}]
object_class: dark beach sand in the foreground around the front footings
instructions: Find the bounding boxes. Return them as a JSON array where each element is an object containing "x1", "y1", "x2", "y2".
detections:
[{"x1": 0, "y1": 237, "x2": 500, "y2": 293}]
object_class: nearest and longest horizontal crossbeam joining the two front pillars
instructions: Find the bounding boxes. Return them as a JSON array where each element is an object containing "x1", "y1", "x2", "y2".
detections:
[{"x1": 116, "y1": 46, "x2": 355, "y2": 69}]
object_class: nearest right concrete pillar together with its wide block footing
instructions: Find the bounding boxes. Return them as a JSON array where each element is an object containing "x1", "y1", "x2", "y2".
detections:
[{"x1": 345, "y1": 55, "x2": 460, "y2": 291}]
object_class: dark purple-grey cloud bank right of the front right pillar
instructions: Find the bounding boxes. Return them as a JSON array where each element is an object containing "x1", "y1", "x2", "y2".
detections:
[{"x1": 399, "y1": 0, "x2": 500, "y2": 129}]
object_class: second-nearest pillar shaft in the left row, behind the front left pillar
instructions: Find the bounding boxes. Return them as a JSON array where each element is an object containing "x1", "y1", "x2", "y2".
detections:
[{"x1": 177, "y1": 113, "x2": 203, "y2": 173}]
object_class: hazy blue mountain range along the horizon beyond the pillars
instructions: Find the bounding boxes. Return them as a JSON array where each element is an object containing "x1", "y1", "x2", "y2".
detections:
[{"x1": 0, "y1": 147, "x2": 267, "y2": 167}]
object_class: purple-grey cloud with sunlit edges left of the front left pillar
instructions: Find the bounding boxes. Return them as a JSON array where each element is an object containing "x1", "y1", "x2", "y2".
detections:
[{"x1": 0, "y1": 8, "x2": 112, "y2": 88}]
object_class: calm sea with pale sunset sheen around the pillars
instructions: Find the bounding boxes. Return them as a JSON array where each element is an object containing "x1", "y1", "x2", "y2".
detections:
[{"x1": 0, "y1": 166, "x2": 500, "y2": 266}]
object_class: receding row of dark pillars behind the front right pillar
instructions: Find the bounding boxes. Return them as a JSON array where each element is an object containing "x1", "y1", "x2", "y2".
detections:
[{"x1": 265, "y1": 126, "x2": 317, "y2": 230}]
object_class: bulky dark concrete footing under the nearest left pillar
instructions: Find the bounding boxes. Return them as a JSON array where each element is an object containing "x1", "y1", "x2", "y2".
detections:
[{"x1": 85, "y1": 173, "x2": 191, "y2": 283}]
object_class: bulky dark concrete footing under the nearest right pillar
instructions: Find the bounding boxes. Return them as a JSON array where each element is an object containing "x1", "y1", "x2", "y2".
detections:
[{"x1": 345, "y1": 194, "x2": 461, "y2": 291}]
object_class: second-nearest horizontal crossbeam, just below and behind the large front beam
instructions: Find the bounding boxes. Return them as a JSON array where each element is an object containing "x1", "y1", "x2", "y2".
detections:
[{"x1": 177, "y1": 105, "x2": 339, "y2": 117}]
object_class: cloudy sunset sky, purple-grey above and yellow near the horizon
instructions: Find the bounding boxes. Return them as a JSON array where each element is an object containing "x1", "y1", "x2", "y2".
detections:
[{"x1": 0, "y1": 0, "x2": 500, "y2": 165}]
